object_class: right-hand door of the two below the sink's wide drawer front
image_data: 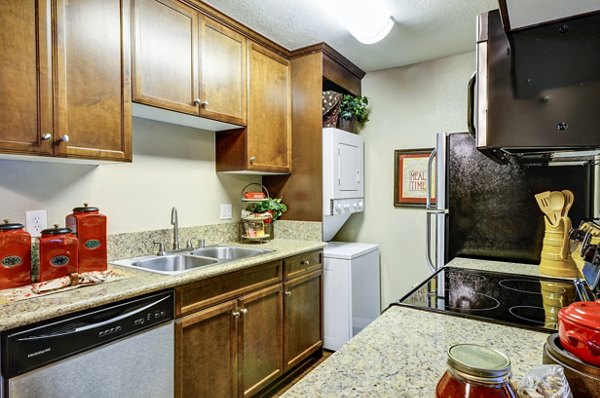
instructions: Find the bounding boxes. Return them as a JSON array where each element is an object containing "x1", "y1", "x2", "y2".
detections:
[{"x1": 239, "y1": 284, "x2": 283, "y2": 397}]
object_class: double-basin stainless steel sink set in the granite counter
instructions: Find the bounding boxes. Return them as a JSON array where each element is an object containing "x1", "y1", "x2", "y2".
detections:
[{"x1": 114, "y1": 254, "x2": 219, "y2": 275}]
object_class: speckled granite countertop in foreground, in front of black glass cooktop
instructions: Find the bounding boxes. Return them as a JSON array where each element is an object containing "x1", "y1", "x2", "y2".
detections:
[{"x1": 284, "y1": 307, "x2": 548, "y2": 398}]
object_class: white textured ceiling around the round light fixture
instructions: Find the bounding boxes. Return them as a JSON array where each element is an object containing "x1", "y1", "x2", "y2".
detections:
[{"x1": 204, "y1": 0, "x2": 498, "y2": 72}]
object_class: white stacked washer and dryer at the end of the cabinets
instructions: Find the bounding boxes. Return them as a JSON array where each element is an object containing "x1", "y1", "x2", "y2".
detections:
[{"x1": 323, "y1": 128, "x2": 381, "y2": 351}]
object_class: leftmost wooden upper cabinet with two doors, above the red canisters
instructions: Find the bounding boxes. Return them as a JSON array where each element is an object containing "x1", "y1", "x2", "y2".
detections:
[{"x1": 0, "y1": 0, "x2": 131, "y2": 161}]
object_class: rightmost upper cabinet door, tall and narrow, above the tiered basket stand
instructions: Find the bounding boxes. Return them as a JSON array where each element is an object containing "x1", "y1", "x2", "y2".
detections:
[{"x1": 247, "y1": 43, "x2": 292, "y2": 172}]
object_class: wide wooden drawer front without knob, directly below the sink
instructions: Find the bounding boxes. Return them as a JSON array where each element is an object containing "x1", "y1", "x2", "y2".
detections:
[{"x1": 175, "y1": 261, "x2": 281, "y2": 316}]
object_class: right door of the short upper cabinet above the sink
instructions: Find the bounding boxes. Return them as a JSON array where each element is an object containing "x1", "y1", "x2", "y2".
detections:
[{"x1": 200, "y1": 17, "x2": 247, "y2": 125}]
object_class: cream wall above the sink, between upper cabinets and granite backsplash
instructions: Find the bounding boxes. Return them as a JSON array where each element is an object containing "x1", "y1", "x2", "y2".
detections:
[{"x1": 0, "y1": 118, "x2": 260, "y2": 234}]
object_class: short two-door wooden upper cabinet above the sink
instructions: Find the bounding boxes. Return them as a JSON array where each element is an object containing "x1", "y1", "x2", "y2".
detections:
[{"x1": 133, "y1": 0, "x2": 247, "y2": 125}]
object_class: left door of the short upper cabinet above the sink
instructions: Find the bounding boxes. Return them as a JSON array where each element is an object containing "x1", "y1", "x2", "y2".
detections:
[{"x1": 133, "y1": 0, "x2": 199, "y2": 115}]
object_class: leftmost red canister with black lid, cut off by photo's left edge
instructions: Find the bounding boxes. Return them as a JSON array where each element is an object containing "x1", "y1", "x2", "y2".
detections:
[{"x1": 0, "y1": 220, "x2": 31, "y2": 289}]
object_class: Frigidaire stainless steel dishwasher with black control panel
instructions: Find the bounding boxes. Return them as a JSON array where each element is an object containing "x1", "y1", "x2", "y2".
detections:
[{"x1": 0, "y1": 291, "x2": 174, "y2": 398}]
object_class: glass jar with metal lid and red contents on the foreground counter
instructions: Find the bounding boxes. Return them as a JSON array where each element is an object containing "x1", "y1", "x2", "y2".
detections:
[{"x1": 435, "y1": 344, "x2": 518, "y2": 398}]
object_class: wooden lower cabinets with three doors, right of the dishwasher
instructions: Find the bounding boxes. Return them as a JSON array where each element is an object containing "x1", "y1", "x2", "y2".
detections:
[{"x1": 175, "y1": 251, "x2": 323, "y2": 398}]
